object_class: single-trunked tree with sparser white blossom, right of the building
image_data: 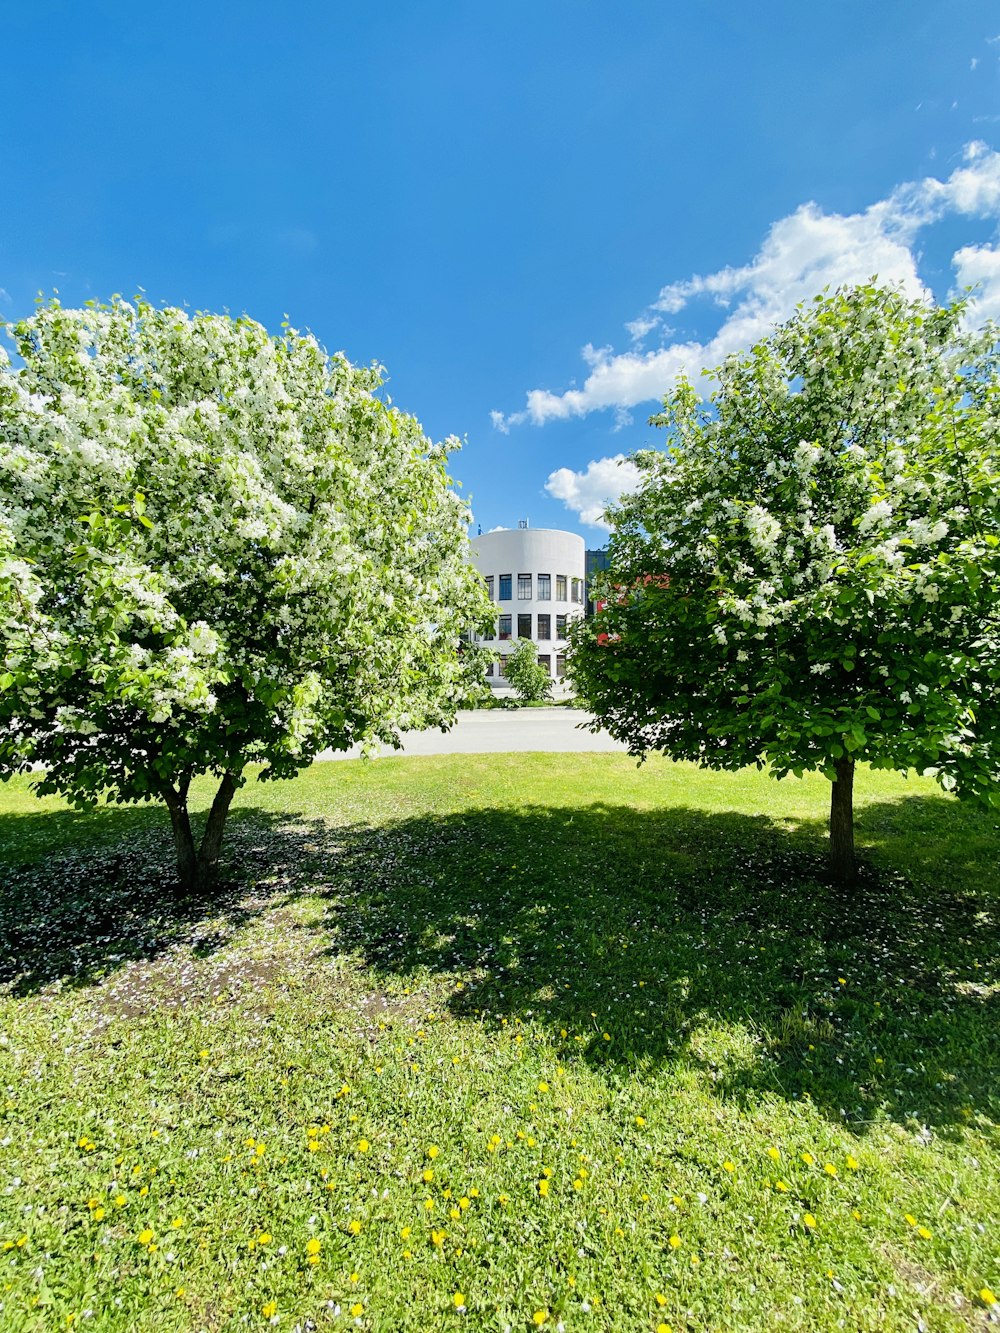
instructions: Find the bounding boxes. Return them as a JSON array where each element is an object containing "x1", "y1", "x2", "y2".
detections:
[{"x1": 571, "y1": 287, "x2": 1000, "y2": 878}]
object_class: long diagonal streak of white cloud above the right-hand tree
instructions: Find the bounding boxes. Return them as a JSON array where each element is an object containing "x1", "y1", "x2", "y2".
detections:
[{"x1": 491, "y1": 141, "x2": 1000, "y2": 429}]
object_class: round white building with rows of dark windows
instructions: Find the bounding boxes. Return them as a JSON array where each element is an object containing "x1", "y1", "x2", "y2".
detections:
[{"x1": 472, "y1": 524, "x2": 587, "y2": 685}]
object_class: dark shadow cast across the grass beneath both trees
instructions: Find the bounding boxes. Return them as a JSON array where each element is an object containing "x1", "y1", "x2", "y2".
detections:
[{"x1": 0, "y1": 796, "x2": 1000, "y2": 1132}]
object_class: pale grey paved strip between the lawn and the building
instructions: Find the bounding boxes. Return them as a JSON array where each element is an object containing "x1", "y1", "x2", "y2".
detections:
[{"x1": 316, "y1": 708, "x2": 625, "y2": 760}]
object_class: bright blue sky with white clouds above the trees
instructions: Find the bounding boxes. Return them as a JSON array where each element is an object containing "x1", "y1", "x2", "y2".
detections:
[{"x1": 0, "y1": 0, "x2": 1000, "y2": 544}]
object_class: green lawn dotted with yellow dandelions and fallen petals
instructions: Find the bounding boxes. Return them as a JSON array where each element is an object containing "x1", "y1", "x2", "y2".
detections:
[{"x1": 0, "y1": 754, "x2": 1000, "y2": 1333}]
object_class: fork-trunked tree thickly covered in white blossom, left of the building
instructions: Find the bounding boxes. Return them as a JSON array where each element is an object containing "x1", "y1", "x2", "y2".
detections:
[{"x1": 0, "y1": 299, "x2": 489, "y2": 886}]
